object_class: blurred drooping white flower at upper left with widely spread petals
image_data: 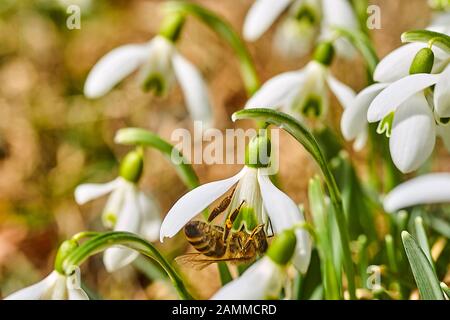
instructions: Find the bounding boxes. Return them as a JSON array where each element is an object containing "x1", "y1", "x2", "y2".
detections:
[{"x1": 84, "y1": 36, "x2": 213, "y2": 126}]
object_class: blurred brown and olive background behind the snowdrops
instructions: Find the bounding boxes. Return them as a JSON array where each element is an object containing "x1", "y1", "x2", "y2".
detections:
[{"x1": 0, "y1": 0, "x2": 450, "y2": 299}]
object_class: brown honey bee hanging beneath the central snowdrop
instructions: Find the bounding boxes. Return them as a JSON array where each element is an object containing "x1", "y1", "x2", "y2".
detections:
[{"x1": 176, "y1": 190, "x2": 268, "y2": 269}]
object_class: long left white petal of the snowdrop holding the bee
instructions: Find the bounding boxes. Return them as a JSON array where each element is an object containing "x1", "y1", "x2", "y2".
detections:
[{"x1": 159, "y1": 167, "x2": 247, "y2": 242}]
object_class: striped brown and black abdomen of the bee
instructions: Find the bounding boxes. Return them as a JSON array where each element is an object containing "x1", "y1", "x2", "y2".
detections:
[{"x1": 184, "y1": 221, "x2": 226, "y2": 258}]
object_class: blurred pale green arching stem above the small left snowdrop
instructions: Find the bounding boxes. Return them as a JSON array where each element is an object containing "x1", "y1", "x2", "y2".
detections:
[{"x1": 114, "y1": 128, "x2": 199, "y2": 189}]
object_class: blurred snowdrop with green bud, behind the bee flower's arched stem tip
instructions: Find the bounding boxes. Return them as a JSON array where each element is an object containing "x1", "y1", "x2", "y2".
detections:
[{"x1": 245, "y1": 42, "x2": 355, "y2": 119}]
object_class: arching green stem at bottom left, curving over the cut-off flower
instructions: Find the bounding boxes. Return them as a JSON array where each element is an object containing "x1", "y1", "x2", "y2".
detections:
[{"x1": 62, "y1": 232, "x2": 193, "y2": 300}]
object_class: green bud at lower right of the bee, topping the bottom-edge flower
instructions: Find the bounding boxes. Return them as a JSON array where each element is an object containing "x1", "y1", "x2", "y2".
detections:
[{"x1": 267, "y1": 230, "x2": 297, "y2": 266}]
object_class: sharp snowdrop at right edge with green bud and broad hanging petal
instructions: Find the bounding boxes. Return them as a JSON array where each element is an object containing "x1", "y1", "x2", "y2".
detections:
[{"x1": 367, "y1": 48, "x2": 450, "y2": 173}]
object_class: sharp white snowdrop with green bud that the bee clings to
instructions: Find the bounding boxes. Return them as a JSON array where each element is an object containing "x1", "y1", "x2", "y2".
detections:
[{"x1": 160, "y1": 136, "x2": 311, "y2": 272}]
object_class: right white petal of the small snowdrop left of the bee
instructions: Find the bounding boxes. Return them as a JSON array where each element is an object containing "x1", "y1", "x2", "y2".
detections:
[{"x1": 138, "y1": 192, "x2": 162, "y2": 241}]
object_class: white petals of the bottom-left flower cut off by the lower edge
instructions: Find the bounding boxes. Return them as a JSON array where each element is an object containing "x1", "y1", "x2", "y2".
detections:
[{"x1": 5, "y1": 271, "x2": 89, "y2": 300}]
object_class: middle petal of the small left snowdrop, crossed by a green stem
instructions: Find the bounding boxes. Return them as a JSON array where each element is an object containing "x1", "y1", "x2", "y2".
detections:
[{"x1": 103, "y1": 190, "x2": 141, "y2": 272}]
